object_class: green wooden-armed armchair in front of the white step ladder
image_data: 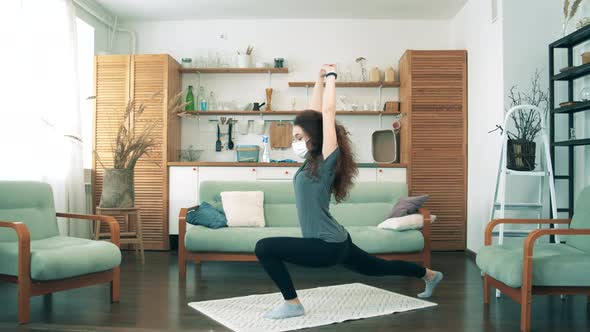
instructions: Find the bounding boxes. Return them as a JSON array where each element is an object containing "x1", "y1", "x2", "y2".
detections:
[{"x1": 476, "y1": 187, "x2": 590, "y2": 332}]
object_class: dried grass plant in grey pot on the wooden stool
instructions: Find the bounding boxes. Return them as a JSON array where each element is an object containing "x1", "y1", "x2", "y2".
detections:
[{"x1": 94, "y1": 92, "x2": 185, "y2": 208}]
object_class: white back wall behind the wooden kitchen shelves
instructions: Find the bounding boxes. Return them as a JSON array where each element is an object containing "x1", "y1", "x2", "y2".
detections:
[{"x1": 116, "y1": 19, "x2": 450, "y2": 162}]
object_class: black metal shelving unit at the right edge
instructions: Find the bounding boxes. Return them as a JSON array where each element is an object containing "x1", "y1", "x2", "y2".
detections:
[{"x1": 549, "y1": 26, "x2": 590, "y2": 220}]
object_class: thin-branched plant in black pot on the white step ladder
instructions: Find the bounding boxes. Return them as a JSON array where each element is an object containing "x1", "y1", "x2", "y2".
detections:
[{"x1": 506, "y1": 70, "x2": 549, "y2": 171}]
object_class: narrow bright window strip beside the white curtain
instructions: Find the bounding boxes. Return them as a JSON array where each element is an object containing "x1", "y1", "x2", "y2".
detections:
[{"x1": 76, "y1": 18, "x2": 94, "y2": 169}]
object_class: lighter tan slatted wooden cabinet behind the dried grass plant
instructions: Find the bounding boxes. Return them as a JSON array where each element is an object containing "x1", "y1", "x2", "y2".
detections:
[{"x1": 93, "y1": 55, "x2": 180, "y2": 250}]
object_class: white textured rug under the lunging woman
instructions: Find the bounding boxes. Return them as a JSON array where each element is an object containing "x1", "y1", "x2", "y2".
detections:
[{"x1": 188, "y1": 283, "x2": 436, "y2": 332}]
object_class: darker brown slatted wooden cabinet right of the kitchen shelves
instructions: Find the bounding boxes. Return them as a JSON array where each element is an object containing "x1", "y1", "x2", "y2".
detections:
[{"x1": 400, "y1": 50, "x2": 467, "y2": 250}]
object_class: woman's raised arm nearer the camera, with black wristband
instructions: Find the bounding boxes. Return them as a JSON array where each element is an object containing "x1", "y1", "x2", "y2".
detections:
[{"x1": 322, "y1": 65, "x2": 338, "y2": 159}]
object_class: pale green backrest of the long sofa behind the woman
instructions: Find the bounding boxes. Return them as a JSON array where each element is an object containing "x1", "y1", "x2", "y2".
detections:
[{"x1": 199, "y1": 181, "x2": 407, "y2": 227}]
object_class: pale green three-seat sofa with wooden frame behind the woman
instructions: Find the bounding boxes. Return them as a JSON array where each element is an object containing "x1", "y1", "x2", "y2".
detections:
[{"x1": 178, "y1": 181, "x2": 430, "y2": 279}]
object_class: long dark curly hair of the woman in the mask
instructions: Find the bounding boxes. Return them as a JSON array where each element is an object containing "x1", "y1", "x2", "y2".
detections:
[{"x1": 294, "y1": 110, "x2": 358, "y2": 203}]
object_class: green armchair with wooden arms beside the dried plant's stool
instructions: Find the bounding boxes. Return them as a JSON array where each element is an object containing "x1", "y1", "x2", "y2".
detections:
[{"x1": 0, "y1": 181, "x2": 121, "y2": 324}]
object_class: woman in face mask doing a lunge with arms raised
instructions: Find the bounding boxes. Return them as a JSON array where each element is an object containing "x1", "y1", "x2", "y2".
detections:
[{"x1": 255, "y1": 65, "x2": 443, "y2": 319}]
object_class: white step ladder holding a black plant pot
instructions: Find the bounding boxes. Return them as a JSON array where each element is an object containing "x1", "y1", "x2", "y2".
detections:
[{"x1": 490, "y1": 105, "x2": 559, "y2": 297}]
